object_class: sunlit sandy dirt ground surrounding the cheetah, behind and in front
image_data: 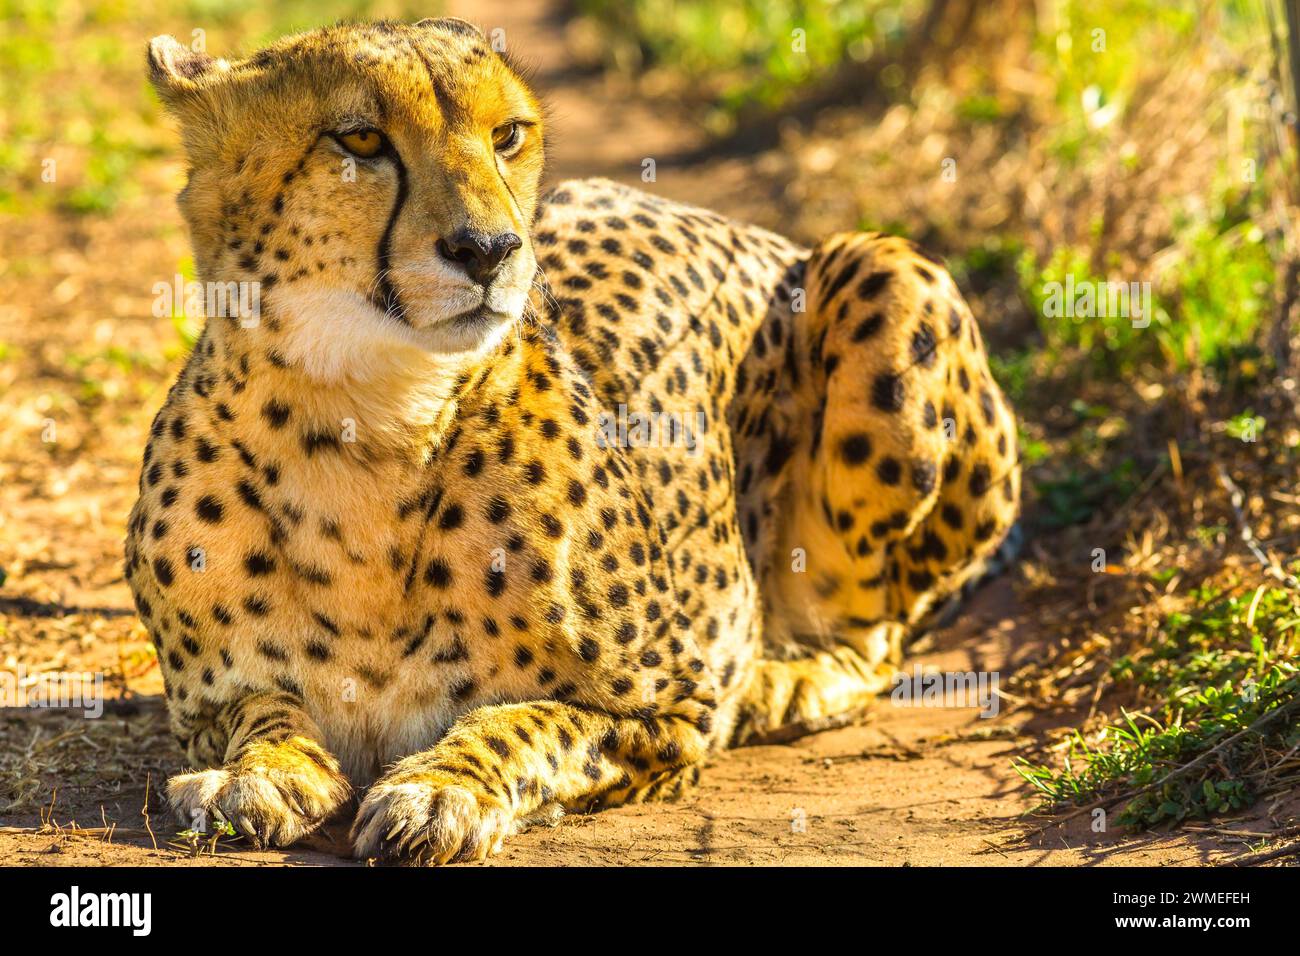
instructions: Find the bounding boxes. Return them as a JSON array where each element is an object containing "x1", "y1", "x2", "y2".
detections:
[{"x1": 0, "y1": 0, "x2": 1300, "y2": 866}]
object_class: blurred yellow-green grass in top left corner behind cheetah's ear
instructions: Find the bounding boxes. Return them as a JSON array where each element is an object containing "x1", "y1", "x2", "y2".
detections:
[{"x1": 0, "y1": 0, "x2": 437, "y2": 215}]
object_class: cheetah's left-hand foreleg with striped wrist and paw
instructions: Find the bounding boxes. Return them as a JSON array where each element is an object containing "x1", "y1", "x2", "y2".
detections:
[{"x1": 166, "y1": 692, "x2": 350, "y2": 847}]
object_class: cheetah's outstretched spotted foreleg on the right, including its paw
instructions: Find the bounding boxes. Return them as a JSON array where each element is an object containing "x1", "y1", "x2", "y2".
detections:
[{"x1": 352, "y1": 701, "x2": 707, "y2": 864}]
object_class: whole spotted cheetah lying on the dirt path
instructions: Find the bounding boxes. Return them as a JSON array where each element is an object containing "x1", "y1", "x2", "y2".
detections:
[{"x1": 125, "y1": 18, "x2": 1021, "y2": 864}]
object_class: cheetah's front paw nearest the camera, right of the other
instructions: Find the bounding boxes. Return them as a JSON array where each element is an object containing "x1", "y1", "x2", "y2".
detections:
[{"x1": 352, "y1": 774, "x2": 517, "y2": 865}]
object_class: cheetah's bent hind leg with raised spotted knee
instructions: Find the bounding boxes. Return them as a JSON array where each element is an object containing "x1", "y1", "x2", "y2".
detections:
[{"x1": 737, "y1": 233, "x2": 1018, "y2": 741}]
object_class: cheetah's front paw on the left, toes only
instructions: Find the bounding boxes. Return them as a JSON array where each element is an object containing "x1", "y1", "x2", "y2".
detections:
[{"x1": 166, "y1": 749, "x2": 348, "y2": 847}]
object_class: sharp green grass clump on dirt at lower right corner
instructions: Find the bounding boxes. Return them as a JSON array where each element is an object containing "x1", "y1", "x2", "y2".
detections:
[{"x1": 1017, "y1": 587, "x2": 1300, "y2": 826}]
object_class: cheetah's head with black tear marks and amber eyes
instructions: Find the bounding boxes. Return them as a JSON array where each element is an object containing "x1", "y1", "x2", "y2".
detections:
[{"x1": 150, "y1": 20, "x2": 543, "y2": 362}]
